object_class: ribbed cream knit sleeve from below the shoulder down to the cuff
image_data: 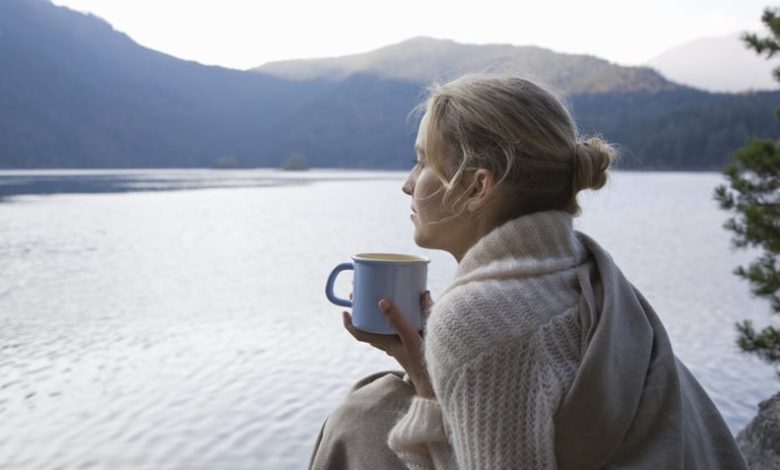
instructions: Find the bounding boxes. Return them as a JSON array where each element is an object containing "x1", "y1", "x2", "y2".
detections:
[{"x1": 388, "y1": 336, "x2": 561, "y2": 470}]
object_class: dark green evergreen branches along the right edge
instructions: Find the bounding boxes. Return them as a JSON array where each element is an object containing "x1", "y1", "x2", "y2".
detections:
[{"x1": 715, "y1": 5, "x2": 780, "y2": 366}]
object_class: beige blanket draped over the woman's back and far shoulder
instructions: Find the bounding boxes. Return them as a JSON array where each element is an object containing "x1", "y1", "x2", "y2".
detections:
[{"x1": 555, "y1": 234, "x2": 747, "y2": 470}]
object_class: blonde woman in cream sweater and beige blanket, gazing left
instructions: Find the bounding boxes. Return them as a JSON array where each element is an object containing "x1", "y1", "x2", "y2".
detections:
[{"x1": 312, "y1": 76, "x2": 746, "y2": 470}]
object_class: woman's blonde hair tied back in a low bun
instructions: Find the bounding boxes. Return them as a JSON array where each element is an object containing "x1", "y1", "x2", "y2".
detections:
[{"x1": 423, "y1": 75, "x2": 616, "y2": 215}]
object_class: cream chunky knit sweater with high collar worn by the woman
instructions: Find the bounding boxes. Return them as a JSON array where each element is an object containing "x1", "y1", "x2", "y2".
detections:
[{"x1": 389, "y1": 212, "x2": 590, "y2": 469}]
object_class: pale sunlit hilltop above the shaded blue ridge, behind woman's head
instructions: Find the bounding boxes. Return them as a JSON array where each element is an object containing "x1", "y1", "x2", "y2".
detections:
[{"x1": 253, "y1": 37, "x2": 680, "y2": 94}]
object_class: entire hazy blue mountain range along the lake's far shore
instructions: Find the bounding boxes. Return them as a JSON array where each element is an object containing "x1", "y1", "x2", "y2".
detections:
[{"x1": 0, "y1": 0, "x2": 780, "y2": 170}]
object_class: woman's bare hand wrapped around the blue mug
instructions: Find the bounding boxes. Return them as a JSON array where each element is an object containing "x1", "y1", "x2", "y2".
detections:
[{"x1": 343, "y1": 292, "x2": 434, "y2": 398}]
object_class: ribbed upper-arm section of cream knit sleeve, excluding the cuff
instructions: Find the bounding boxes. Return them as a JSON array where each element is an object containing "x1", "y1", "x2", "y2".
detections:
[{"x1": 439, "y1": 337, "x2": 561, "y2": 470}]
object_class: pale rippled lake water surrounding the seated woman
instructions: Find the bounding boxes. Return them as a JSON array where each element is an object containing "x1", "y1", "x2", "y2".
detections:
[{"x1": 0, "y1": 170, "x2": 780, "y2": 470}]
